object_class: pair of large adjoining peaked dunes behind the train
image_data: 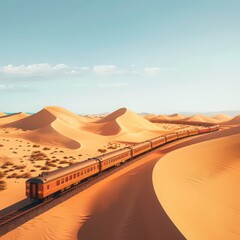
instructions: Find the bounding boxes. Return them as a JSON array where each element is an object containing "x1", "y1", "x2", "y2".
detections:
[{"x1": 1, "y1": 106, "x2": 165, "y2": 149}]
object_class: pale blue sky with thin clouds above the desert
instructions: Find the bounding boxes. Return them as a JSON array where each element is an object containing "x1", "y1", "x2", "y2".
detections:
[{"x1": 0, "y1": 0, "x2": 240, "y2": 114}]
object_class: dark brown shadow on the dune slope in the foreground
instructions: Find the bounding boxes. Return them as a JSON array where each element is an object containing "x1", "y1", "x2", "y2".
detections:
[{"x1": 78, "y1": 152, "x2": 185, "y2": 240}]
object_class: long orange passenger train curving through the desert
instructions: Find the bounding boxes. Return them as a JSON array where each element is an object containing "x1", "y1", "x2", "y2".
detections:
[{"x1": 26, "y1": 125, "x2": 219, "y2": 201}]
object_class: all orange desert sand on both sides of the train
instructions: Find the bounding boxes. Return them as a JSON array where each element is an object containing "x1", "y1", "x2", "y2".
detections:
[{"x1": 0, "y1": 107, "x2": 240, "y2": 240}]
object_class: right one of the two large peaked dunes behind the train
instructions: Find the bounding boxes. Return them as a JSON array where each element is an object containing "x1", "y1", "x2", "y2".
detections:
[{"x1": 84, "y1": 108, "x2": 160, "y2": 136}]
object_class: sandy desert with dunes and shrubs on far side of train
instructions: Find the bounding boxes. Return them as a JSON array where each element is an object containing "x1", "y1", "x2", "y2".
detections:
[{"x1": 0, "y1": 106, "x2": 186, "y2": 209}]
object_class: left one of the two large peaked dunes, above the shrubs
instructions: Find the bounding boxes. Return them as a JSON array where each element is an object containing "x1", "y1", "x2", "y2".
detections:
[{"x1": 3, "y1": 107, "x2": 91, "y2": 149}]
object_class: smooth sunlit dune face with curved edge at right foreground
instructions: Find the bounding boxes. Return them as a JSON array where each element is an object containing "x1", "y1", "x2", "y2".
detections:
[{"x1": 153, "y1": 127, "x2": 240, "y2": 240}]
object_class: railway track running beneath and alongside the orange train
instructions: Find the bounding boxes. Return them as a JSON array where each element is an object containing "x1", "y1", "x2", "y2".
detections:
[{"x1": 0, "y1": 124, "x2": 218, "y2": 237}]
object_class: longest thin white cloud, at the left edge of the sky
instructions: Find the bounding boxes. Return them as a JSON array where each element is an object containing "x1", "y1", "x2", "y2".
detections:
[{"x1": 0, "y1": 63, "x2": 89, "y2": 77}]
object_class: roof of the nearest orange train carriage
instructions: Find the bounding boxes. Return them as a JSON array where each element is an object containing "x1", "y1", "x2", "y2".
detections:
[{"x1": 27, "y1": 159, "x2": 98, "y2": 183}]
